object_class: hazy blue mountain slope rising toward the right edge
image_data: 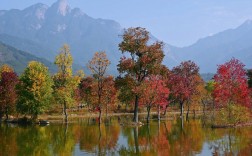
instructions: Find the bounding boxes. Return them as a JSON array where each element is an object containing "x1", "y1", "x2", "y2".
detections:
[{"x1": 171, "y1": 20, "x2": 252, "y2": 73}]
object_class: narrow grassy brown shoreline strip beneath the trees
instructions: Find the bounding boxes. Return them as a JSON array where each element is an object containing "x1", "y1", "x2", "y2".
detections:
[{"x1": 0, "y1": 112, "x2": 252, "y2": 129}]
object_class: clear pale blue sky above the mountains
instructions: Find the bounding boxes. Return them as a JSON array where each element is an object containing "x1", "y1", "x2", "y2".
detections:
[{"x1": 0, "y1": 0, "x2": 252, "y2": 47}]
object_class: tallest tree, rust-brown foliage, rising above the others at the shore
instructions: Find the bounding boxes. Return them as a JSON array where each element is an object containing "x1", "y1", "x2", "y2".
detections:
[{"x1": 118, "y1": 27, "x2": 164, "y2": 122}]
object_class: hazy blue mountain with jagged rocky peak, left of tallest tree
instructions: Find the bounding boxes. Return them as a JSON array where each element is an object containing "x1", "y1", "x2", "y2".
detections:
[{"x1": 0, "y1": 0, "x2": 123, "y2": 74}]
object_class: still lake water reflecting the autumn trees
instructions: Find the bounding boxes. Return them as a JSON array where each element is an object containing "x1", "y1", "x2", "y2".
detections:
[{"x1": 0, "y1": 118, "x2": 252, "y2": 156}]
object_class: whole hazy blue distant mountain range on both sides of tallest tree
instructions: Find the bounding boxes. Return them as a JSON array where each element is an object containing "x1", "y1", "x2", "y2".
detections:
[{"x1": 0, "y1": 0, "x2": 252, "y2": 73}]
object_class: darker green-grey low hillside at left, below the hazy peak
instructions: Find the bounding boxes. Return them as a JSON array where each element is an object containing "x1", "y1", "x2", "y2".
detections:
[{"x1": 0, "y1": 42, "x2": 57, "y2": 74}]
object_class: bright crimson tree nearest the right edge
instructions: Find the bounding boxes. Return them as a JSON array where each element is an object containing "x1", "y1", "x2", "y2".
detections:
[{"x1": 213, "y1": 58, "x2": 251, "y2": 122}]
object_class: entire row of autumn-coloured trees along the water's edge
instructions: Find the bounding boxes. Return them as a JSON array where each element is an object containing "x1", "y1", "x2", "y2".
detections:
[{"x1": 0, "y1": 27, "x2": 252, "y2": 123}]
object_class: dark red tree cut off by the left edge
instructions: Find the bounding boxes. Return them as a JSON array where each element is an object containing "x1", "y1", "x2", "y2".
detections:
[{"x1": 0, "y1": 65, "x2": 18, "y2": 120}]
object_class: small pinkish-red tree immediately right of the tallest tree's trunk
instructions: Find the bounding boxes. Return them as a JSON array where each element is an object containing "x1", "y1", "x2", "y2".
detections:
[{"x1": 140, "y1": 75, "x2": 169, "y2": 122}]
